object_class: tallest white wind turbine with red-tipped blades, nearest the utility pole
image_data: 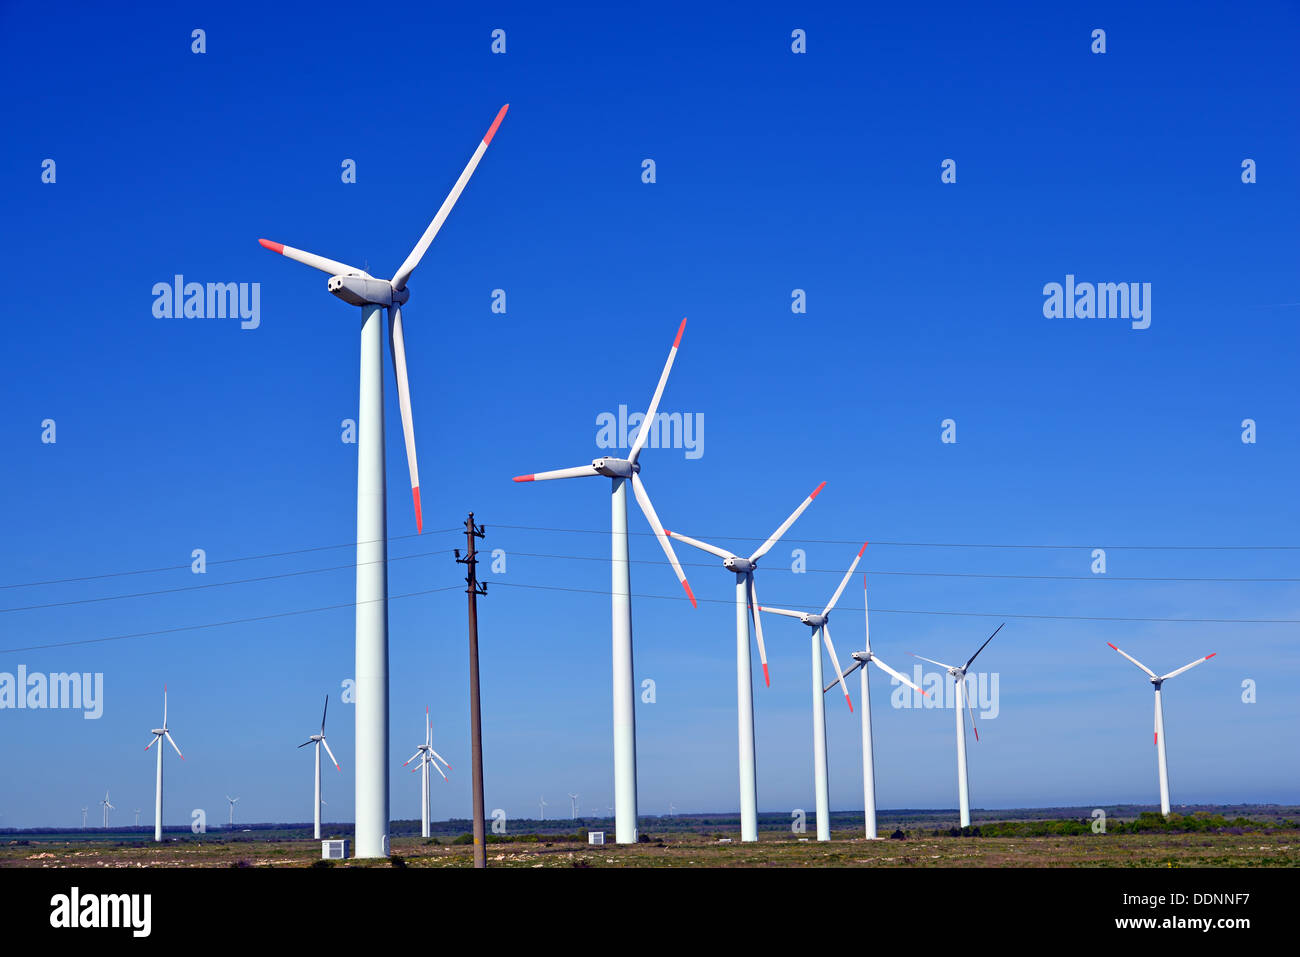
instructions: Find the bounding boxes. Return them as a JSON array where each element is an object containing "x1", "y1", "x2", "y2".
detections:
[{"x1": 259, "y1": 104, "x2": 510, "y2": 857}]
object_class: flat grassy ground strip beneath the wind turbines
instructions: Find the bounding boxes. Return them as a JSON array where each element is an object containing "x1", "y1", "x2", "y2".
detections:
[{"x1": 0, "y1": 830, "x2": 1300, "y2": 867}]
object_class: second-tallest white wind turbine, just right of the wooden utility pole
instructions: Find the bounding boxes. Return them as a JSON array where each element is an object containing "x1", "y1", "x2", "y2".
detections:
[{"x1": 515, "y1": 319, "x2": 696, "y2": 844}]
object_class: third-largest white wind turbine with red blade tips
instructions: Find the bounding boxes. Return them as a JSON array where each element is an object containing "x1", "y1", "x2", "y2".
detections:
[{"x1": 664, "y1": 482, "x2": 826, "y2": 841}]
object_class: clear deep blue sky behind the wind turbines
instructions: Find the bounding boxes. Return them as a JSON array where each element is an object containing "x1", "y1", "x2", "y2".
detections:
[{"x1": 0, "y1": 3, "x2": 1300, "y2": 826}]
